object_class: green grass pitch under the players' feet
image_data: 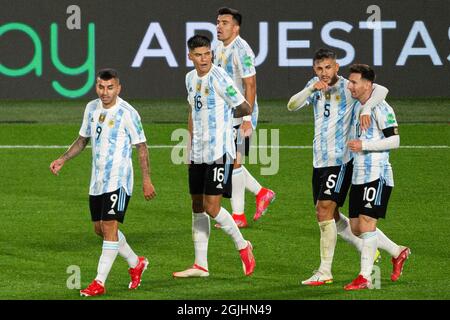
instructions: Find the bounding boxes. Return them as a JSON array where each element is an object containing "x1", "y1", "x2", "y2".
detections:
[{"x1": 0, "y1": 99, "x2": 450, "y2": 300}]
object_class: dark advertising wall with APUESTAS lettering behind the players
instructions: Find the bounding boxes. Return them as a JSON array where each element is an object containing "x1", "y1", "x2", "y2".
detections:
[{"x1": 0, "y1": 0, "x2": 450, "y2": 99}]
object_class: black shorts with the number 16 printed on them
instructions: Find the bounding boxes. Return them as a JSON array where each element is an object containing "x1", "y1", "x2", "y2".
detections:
[{"x1": 189, "y1": 155, "x2": 233, "y2": 198}]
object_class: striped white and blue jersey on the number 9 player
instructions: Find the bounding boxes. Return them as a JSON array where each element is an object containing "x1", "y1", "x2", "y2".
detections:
[{"x1": 79, "y1": 97, "x2": 146, "y2": 196}]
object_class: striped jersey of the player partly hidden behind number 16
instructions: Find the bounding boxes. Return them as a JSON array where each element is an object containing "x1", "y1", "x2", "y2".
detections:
[{"x1": 214, "y1": 36, "x2": 259, "y2": 129}]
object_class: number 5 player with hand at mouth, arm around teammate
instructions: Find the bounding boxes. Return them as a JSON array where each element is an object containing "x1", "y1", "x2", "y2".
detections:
[{"x1": 287, "y1": 48, "x2": 394, "y2": 286}]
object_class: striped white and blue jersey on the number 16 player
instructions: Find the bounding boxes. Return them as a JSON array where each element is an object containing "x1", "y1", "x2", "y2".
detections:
[{"x1": 186, "y1": 65, "x2": 245, "y2": 163}]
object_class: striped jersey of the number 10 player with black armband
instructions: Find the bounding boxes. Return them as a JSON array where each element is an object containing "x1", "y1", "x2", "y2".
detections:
[{"x1": 350, "y1": 101, "x2": 398, "y2": 187}]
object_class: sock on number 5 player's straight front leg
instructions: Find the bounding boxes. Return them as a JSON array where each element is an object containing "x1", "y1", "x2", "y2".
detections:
[{"x1": 319, "y1": 219, "x2": 337, "y2": 275}]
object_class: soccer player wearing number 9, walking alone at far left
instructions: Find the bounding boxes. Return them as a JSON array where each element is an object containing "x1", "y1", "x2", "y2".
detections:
[{"x1": 50, "y1": 69, "x2": 156, "y2": 296}]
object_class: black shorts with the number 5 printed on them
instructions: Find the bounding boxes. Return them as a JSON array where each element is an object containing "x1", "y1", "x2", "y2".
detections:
[{"x1": 312, "y1": 159, "x2": 353, "y2": 207}]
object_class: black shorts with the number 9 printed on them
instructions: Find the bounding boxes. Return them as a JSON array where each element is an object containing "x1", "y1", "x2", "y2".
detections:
[{"x1": 89, "y1": 188, "x2": 131, "y2": 223}]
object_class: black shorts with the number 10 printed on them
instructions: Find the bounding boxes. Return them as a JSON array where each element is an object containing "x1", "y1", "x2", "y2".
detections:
[{"x1": 349, "y1": 179, "x2": 393, "y2": 219}]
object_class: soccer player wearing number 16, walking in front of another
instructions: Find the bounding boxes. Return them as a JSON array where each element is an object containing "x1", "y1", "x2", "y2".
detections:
[{"x1": 173, "y1": 35, "x2": 256, "y2": 278}]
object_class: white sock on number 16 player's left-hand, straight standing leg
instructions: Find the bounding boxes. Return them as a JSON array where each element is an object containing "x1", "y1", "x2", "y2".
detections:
[{"x1": 192, "y1": 212, "x2": 211, "y2": 270}]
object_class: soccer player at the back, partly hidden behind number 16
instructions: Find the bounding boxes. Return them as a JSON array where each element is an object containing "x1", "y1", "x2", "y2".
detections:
[{"x1": 214, "y1": 7, "x2": 275, "y2": 228}]
